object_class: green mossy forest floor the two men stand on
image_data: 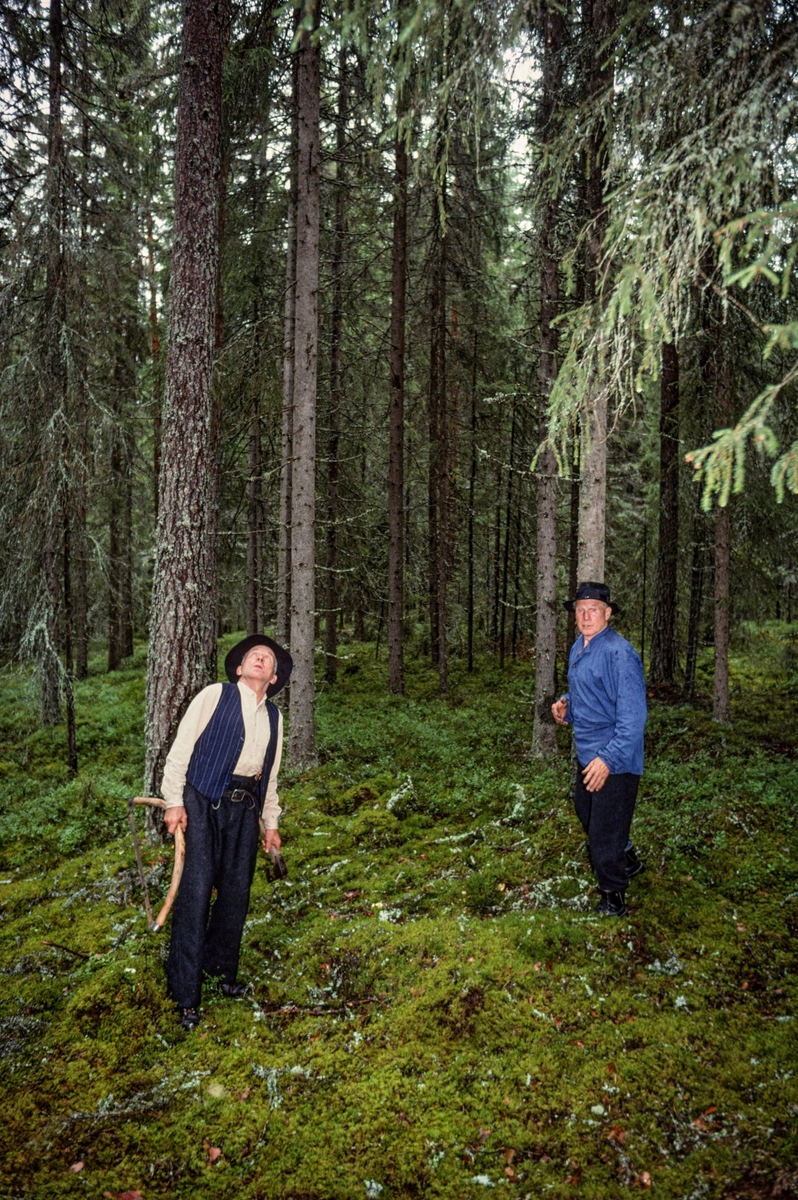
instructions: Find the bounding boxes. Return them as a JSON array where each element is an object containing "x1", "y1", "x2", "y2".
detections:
[{"x1": 0, "y1": 623, "x2": 798, "y2": 1200}]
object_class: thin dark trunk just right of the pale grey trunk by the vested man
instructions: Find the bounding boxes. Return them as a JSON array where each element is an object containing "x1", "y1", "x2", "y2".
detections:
[{"x1": 324, "y1": 40, "x2": 348, "y2": 684}]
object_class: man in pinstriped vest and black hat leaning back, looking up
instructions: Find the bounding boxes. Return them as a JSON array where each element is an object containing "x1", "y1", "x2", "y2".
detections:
[{"x1": 161, "y1": 634, "x2": 293, "y2": 1030}]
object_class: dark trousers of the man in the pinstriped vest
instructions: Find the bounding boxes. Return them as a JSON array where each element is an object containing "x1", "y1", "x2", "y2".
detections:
[{"x1": 167, "y1": 781, "x2": 259, "y2": 1008}]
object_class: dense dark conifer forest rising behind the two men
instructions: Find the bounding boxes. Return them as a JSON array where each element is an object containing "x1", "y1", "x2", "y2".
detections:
[{"x1": 0, "y1": 0, "x2": 798, "y2": 787}]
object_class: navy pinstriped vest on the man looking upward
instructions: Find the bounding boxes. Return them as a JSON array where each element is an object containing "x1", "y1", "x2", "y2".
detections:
[{"x1": 186, "y1": 683, "x2": 280, "y2": 802}]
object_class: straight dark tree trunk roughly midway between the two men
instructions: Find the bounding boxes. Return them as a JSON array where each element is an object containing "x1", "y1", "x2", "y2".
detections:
[{"x1": 388, "y1": 117, "x2": 408, "y2": 696}]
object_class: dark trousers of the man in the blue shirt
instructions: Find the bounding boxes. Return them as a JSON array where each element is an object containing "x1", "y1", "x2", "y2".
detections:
[{"x1": 574, "y1": 763, "x2": 640, "y2": 892}]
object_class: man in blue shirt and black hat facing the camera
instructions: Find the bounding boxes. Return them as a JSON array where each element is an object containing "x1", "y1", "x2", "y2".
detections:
[{"x1": 552, "y1": 583, "x2": 647, "y2": 917}]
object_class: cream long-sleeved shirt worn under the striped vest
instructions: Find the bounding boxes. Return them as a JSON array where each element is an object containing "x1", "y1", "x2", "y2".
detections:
[{"x1": 161, "y1": 679, "x2": 283, "y2": 829}]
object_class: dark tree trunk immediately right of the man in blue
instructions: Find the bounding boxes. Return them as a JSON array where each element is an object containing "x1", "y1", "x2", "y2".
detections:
[{"x1": 648, "y1": 342, "x2": 679, "y2": 683}]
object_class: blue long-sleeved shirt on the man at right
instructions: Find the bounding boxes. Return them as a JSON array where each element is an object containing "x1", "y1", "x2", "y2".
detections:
[{"x1": 565, "y1": 625, "x2": 647, "y2": 775}]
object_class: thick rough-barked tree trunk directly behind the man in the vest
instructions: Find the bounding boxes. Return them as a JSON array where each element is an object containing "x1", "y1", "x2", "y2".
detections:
[{"x1": 144, "y1": 0, "x2": 229, "y2": 811}]
